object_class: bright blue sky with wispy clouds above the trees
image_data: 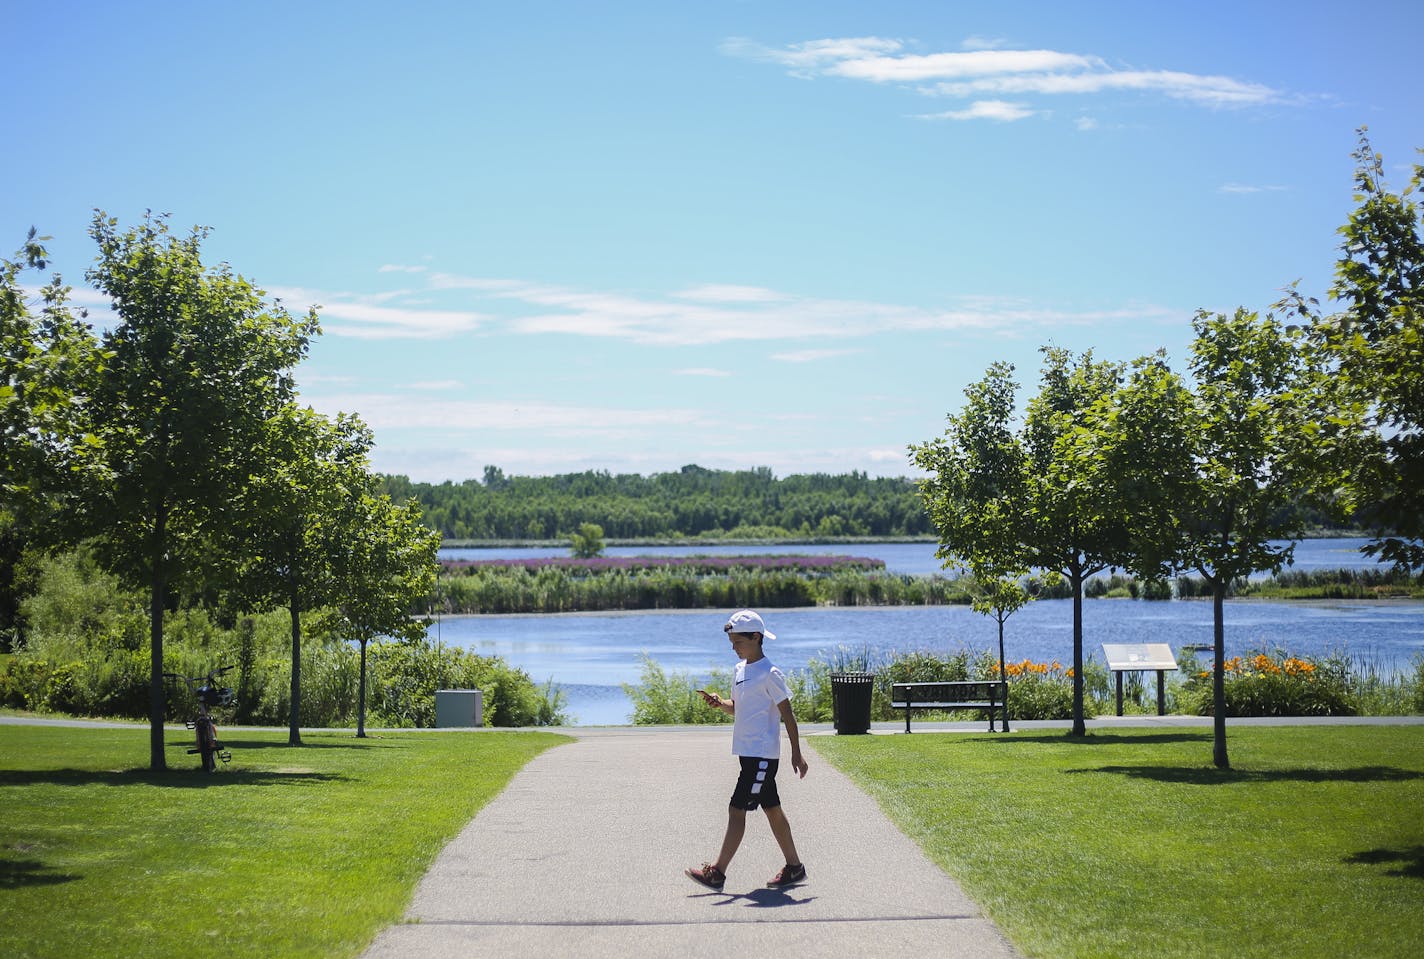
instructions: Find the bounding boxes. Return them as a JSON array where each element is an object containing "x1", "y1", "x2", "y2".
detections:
[{"x1": 0, "y1": 0, "x2": 1424, "y2": 482}]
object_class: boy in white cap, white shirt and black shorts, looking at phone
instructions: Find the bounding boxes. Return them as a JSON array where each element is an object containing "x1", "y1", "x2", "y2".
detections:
[{"x1": 686, "y1": 610, "x2": 807, "y2": 892}]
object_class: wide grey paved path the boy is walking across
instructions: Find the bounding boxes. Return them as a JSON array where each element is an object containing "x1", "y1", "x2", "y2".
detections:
[{"x1": 365, "y1": 727, "x2": 1018, "y2": 959}]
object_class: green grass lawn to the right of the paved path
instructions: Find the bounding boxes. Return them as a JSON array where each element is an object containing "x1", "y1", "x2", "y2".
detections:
[{"x1": 812, "y1": 725, "x2": 1424, "y2": 959}]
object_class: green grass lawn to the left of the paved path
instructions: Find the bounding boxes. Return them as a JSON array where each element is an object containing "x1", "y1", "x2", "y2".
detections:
[{"x1": 0, "y1": 725, "x2": 567, "y2": 959}]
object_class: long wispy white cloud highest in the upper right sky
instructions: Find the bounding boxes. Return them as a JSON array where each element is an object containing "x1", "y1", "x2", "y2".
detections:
[{"x1": 722, "y1": 37, "x2": 1286, "y2": 111}]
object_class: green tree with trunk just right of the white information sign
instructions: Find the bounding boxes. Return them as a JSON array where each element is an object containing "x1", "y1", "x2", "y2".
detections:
[{"x1": 1178, "y1": 309, "x2": 1356, "y2": 769}]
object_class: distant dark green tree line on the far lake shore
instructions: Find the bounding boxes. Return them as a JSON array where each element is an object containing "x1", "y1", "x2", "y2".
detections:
[{"x1": 383, "y1": 466, "x2": 934, "y2": 540}]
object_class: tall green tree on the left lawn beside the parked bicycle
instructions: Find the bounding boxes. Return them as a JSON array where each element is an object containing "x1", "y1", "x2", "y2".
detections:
[{"x1": 88, "y1": 212, "x2": 318, "y2": 769}]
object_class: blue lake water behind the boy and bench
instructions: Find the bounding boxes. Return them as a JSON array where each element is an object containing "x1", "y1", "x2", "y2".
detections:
[{"x1": 430, "y1": 540, "x2": 1424, "y2": 725}]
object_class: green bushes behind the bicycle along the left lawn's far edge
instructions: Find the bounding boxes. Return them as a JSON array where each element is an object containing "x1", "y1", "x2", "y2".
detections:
[{"x1": 0, "y1": 550, "x2": 567, "y2": 727}]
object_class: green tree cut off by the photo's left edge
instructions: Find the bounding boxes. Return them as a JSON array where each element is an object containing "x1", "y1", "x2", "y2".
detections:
[{"x1": 0, "y1": 228, "x2": 103, "y2": 650}]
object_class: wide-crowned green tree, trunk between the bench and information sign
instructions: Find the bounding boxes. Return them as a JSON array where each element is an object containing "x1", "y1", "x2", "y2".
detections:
[{"x1": 911, "y1": 348, "x2": 1186, "y2": 735}]
